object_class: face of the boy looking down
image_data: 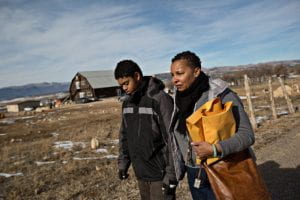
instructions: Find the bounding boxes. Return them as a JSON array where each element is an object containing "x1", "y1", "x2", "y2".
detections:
[{"x1": 117, "y1": 72, "x2": 141, "y2": 94}]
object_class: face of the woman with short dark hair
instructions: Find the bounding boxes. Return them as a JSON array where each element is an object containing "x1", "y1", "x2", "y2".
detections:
[{"x1": 171, "y1": 59, "x2": 201, "y2": 92}]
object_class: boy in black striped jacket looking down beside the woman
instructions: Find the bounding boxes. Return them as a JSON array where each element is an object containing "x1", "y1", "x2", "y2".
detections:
[{"x1": 115, "y1": 60, "x2": 177, "y2": 200}]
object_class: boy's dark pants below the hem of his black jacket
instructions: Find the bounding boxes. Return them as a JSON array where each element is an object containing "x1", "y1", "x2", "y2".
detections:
[{"x1": 138, "y1": 180, "x2": 176, "y2": 200}]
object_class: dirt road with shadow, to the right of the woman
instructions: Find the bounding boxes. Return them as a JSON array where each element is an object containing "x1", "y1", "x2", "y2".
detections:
[{"x1": 254, "y1": 113, "x2": 300, "y2": 200}]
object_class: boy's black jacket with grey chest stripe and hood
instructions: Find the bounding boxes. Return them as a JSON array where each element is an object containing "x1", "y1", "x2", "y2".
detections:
[{"x1": 118, "y1": 77, "x2": 176, "y2": 182}]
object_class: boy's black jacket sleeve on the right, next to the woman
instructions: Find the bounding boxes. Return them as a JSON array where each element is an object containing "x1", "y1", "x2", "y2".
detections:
[{"x1": 158, "y1": 92, "x2": 176, "y2": 184}]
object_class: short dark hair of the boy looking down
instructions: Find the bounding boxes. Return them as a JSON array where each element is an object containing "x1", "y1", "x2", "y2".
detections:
[{"x1": 115, "y1": 60, "x2": 143, "y2": 79}]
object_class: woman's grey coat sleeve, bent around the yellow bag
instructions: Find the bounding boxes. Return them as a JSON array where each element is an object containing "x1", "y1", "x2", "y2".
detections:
[{"x1": 219, "y1": 91, "x2": 255, "y2": 156}]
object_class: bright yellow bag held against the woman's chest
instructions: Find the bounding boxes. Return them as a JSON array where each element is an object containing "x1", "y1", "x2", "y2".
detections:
[{"x1": 186, "y1": 97, "x2": 236, "y2": 164}]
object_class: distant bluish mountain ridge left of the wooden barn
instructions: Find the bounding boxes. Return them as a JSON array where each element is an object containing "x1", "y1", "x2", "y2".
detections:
[{"x1": 0, "y1": 82, "x2": 70, "y2": 101}]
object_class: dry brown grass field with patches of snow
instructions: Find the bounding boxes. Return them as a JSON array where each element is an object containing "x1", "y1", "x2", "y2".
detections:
[{"x1": 0, "y1": 77, "x2": 300, "y2": 200}]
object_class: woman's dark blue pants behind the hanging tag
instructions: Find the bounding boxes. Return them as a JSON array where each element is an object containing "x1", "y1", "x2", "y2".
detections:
[{"x1": 187, "y1": 167, "x2": 216, "y2": 200}]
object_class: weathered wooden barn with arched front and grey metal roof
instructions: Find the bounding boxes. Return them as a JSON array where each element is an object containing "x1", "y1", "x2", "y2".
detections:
[{"x1": 69, "y1": 70, "x2": 119, "y2": 101}]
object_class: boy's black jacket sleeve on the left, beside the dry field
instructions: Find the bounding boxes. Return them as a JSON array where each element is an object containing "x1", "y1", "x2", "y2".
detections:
[{"x1": 118, "y1": 108, "x2": 131, "y2": 172}]
